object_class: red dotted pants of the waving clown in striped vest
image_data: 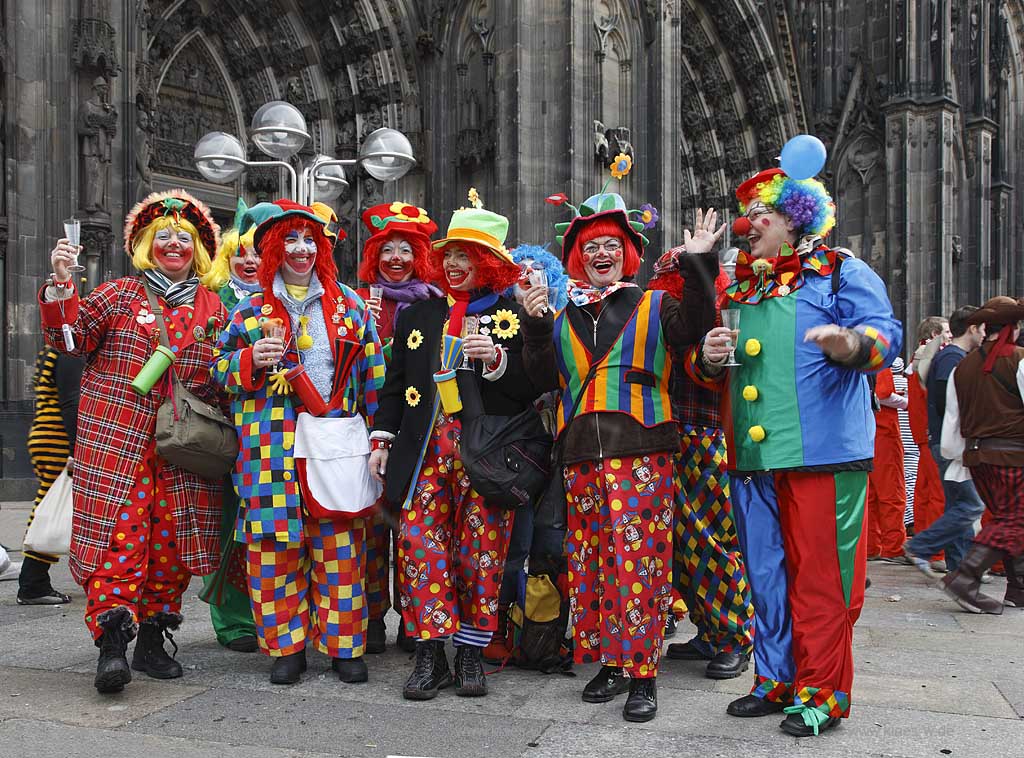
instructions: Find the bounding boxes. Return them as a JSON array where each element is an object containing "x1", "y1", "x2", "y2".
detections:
[{"x1": 564, "y1": 452, "x2": 675, "y2": 679}]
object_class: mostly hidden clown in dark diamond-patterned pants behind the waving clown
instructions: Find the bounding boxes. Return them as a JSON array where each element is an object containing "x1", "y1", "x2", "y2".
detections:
[{"x1": 647, "y1": 247, "x2": 754, "y2": 679}]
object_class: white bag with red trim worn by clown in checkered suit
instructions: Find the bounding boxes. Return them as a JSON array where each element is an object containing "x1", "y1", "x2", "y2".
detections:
[{"x1": 295, "y1": 413, "x2": 382, "y2": 518}]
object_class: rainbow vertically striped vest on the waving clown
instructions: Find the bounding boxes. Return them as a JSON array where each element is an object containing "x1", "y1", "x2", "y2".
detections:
[{"x1": 555, "y1": 290, "x2": 672, "y2": 434}]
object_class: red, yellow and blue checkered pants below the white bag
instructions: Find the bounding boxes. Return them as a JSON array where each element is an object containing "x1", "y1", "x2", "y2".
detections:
[{"x1": 247, "y1": 512, "x2": 368, "y2": 658}]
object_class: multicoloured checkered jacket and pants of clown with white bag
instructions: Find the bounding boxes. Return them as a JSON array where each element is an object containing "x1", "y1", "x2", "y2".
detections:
[{"x1": 211, "y1": 277, "x2": 384, "y2": 658}]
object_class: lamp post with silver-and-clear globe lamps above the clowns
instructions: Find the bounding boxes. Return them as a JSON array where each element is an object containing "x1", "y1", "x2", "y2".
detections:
[{"x1": 194, "y1": 100, "x2": 416, "y2": 205}]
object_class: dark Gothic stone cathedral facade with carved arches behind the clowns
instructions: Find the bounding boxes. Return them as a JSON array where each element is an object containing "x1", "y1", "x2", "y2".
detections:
[{"x1": 0, "y1": 0, "x2": 1024, "y2": 479}]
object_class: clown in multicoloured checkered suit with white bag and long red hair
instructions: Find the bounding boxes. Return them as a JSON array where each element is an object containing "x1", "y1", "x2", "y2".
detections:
[{"x1": 212, "y1": 200, "x2": 384, "y2": 684}]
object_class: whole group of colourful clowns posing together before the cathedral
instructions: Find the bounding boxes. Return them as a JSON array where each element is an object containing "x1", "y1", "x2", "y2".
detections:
[{"x1": 40, "y1": 150, "x2": 901, "y2": 735}]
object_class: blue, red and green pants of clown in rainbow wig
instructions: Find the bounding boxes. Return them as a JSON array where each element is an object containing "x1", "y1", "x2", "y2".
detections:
[{"x1": 730, "y1": 471, "x2": 867, "y2": 721}]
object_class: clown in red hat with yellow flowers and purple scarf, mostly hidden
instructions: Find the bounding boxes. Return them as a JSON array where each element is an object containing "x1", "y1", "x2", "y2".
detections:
[{"x1": 358, "y1": 202, "x2": 441, "y2": 652}]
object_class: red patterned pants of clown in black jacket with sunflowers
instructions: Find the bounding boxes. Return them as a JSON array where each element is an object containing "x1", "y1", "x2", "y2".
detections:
[{"x1": 398, "y1": 415, "x2": 512, "y2": 647}]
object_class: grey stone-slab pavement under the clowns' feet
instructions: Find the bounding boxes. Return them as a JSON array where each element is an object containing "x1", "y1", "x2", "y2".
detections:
[{"x1": 0, "y1": 503, "x2": 1024, "y2": 758}]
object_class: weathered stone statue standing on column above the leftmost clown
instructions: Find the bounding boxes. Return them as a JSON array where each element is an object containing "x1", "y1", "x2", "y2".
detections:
[{"x1": 78, "y1": 77, "x2": 118, "y2": 213}]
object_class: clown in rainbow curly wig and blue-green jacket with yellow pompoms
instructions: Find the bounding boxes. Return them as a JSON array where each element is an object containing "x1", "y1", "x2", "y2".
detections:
[{"x1": 686, "y1": 169, "x2": 902, "y2": 736}]
